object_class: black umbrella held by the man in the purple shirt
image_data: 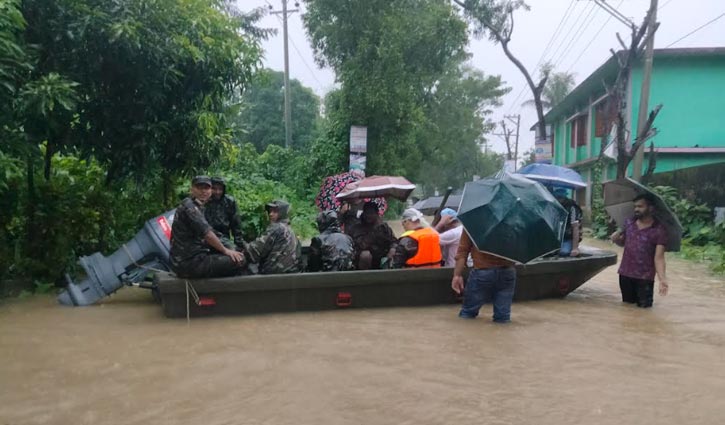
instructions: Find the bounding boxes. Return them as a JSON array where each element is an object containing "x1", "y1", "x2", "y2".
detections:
[{"x1": 604, "y1": 177, "x2": 682, "y2": 252}]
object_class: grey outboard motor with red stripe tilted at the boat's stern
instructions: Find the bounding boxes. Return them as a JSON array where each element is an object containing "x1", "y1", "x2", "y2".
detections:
[{"x1": 58, "y1": 209, "x2": 176, "y2": 306}]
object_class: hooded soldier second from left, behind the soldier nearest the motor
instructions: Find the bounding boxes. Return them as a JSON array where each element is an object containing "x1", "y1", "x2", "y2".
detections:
[{"x1": 204, "y1": 177, "x2": 244, "y2": 249}]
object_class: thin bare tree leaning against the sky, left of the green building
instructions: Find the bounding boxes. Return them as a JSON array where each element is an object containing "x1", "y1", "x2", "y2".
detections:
[{"x1": 453, "y1": 0, "x2": 547, "y2": 142}]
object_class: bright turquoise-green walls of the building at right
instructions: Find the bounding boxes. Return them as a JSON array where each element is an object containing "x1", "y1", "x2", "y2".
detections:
[{"x1": 553, "y1": 56, "x2": 725, "y2": 176}]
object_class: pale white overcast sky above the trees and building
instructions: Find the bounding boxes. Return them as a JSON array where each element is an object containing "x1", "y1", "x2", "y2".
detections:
[{"x1": 237, "y1": 0, "x2": 725, "y2": 154}]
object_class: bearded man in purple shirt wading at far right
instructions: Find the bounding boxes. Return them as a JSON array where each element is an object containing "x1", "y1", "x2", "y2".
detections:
[{"x1": 611, "y1": 194, "x2": 667, "y2": 308}]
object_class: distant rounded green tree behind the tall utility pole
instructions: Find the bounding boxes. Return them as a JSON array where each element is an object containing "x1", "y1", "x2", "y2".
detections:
[{"x1": 238, "y1": 70, "x2": 320, "y2": 152}]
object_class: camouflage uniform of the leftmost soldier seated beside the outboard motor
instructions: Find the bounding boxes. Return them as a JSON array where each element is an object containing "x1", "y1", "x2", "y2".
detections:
[{"x1": 170, "y1": 198, "x2": 244, "y2": 278}]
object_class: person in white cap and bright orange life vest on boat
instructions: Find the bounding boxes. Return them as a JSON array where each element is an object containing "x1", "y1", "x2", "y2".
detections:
[{"x1": 392, "y1": 208, "x2": 443, "y2": 269}]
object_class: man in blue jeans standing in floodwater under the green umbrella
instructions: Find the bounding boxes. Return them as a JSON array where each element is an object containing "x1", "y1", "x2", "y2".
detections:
[{"x1": 451, "y1": 232, "x2": 516, "y2": 323}]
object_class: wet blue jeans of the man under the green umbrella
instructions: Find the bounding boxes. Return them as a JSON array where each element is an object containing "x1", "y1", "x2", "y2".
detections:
[{"x1": 458, "y1": 267, "x2": 516, "y2": 323}]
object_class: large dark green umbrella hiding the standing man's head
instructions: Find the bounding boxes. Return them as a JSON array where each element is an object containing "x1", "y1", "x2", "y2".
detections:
[{"x1": 458, "y1": 173, "x2": 567, "y2": 263}]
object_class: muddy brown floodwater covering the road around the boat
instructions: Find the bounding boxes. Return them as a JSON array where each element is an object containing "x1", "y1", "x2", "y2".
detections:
[{"x1": 0, "y1": 238, "x2": 725, "y2": 425}]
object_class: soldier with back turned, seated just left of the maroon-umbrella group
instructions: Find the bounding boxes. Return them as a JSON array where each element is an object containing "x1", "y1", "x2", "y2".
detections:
[{"x1": 307, "y1": 211, "x2": 355, "y2": 272}]
